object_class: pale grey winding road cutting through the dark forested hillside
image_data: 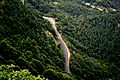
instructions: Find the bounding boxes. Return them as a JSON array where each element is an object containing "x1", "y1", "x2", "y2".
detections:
[{"x1": 43, "y1": 16, "x2": 71, "y2": 73}]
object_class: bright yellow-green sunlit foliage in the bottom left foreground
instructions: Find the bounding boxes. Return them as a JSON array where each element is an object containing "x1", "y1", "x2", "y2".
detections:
[{"x1": 0, "y1": 64, "x2": 46, "y2": 80}]
